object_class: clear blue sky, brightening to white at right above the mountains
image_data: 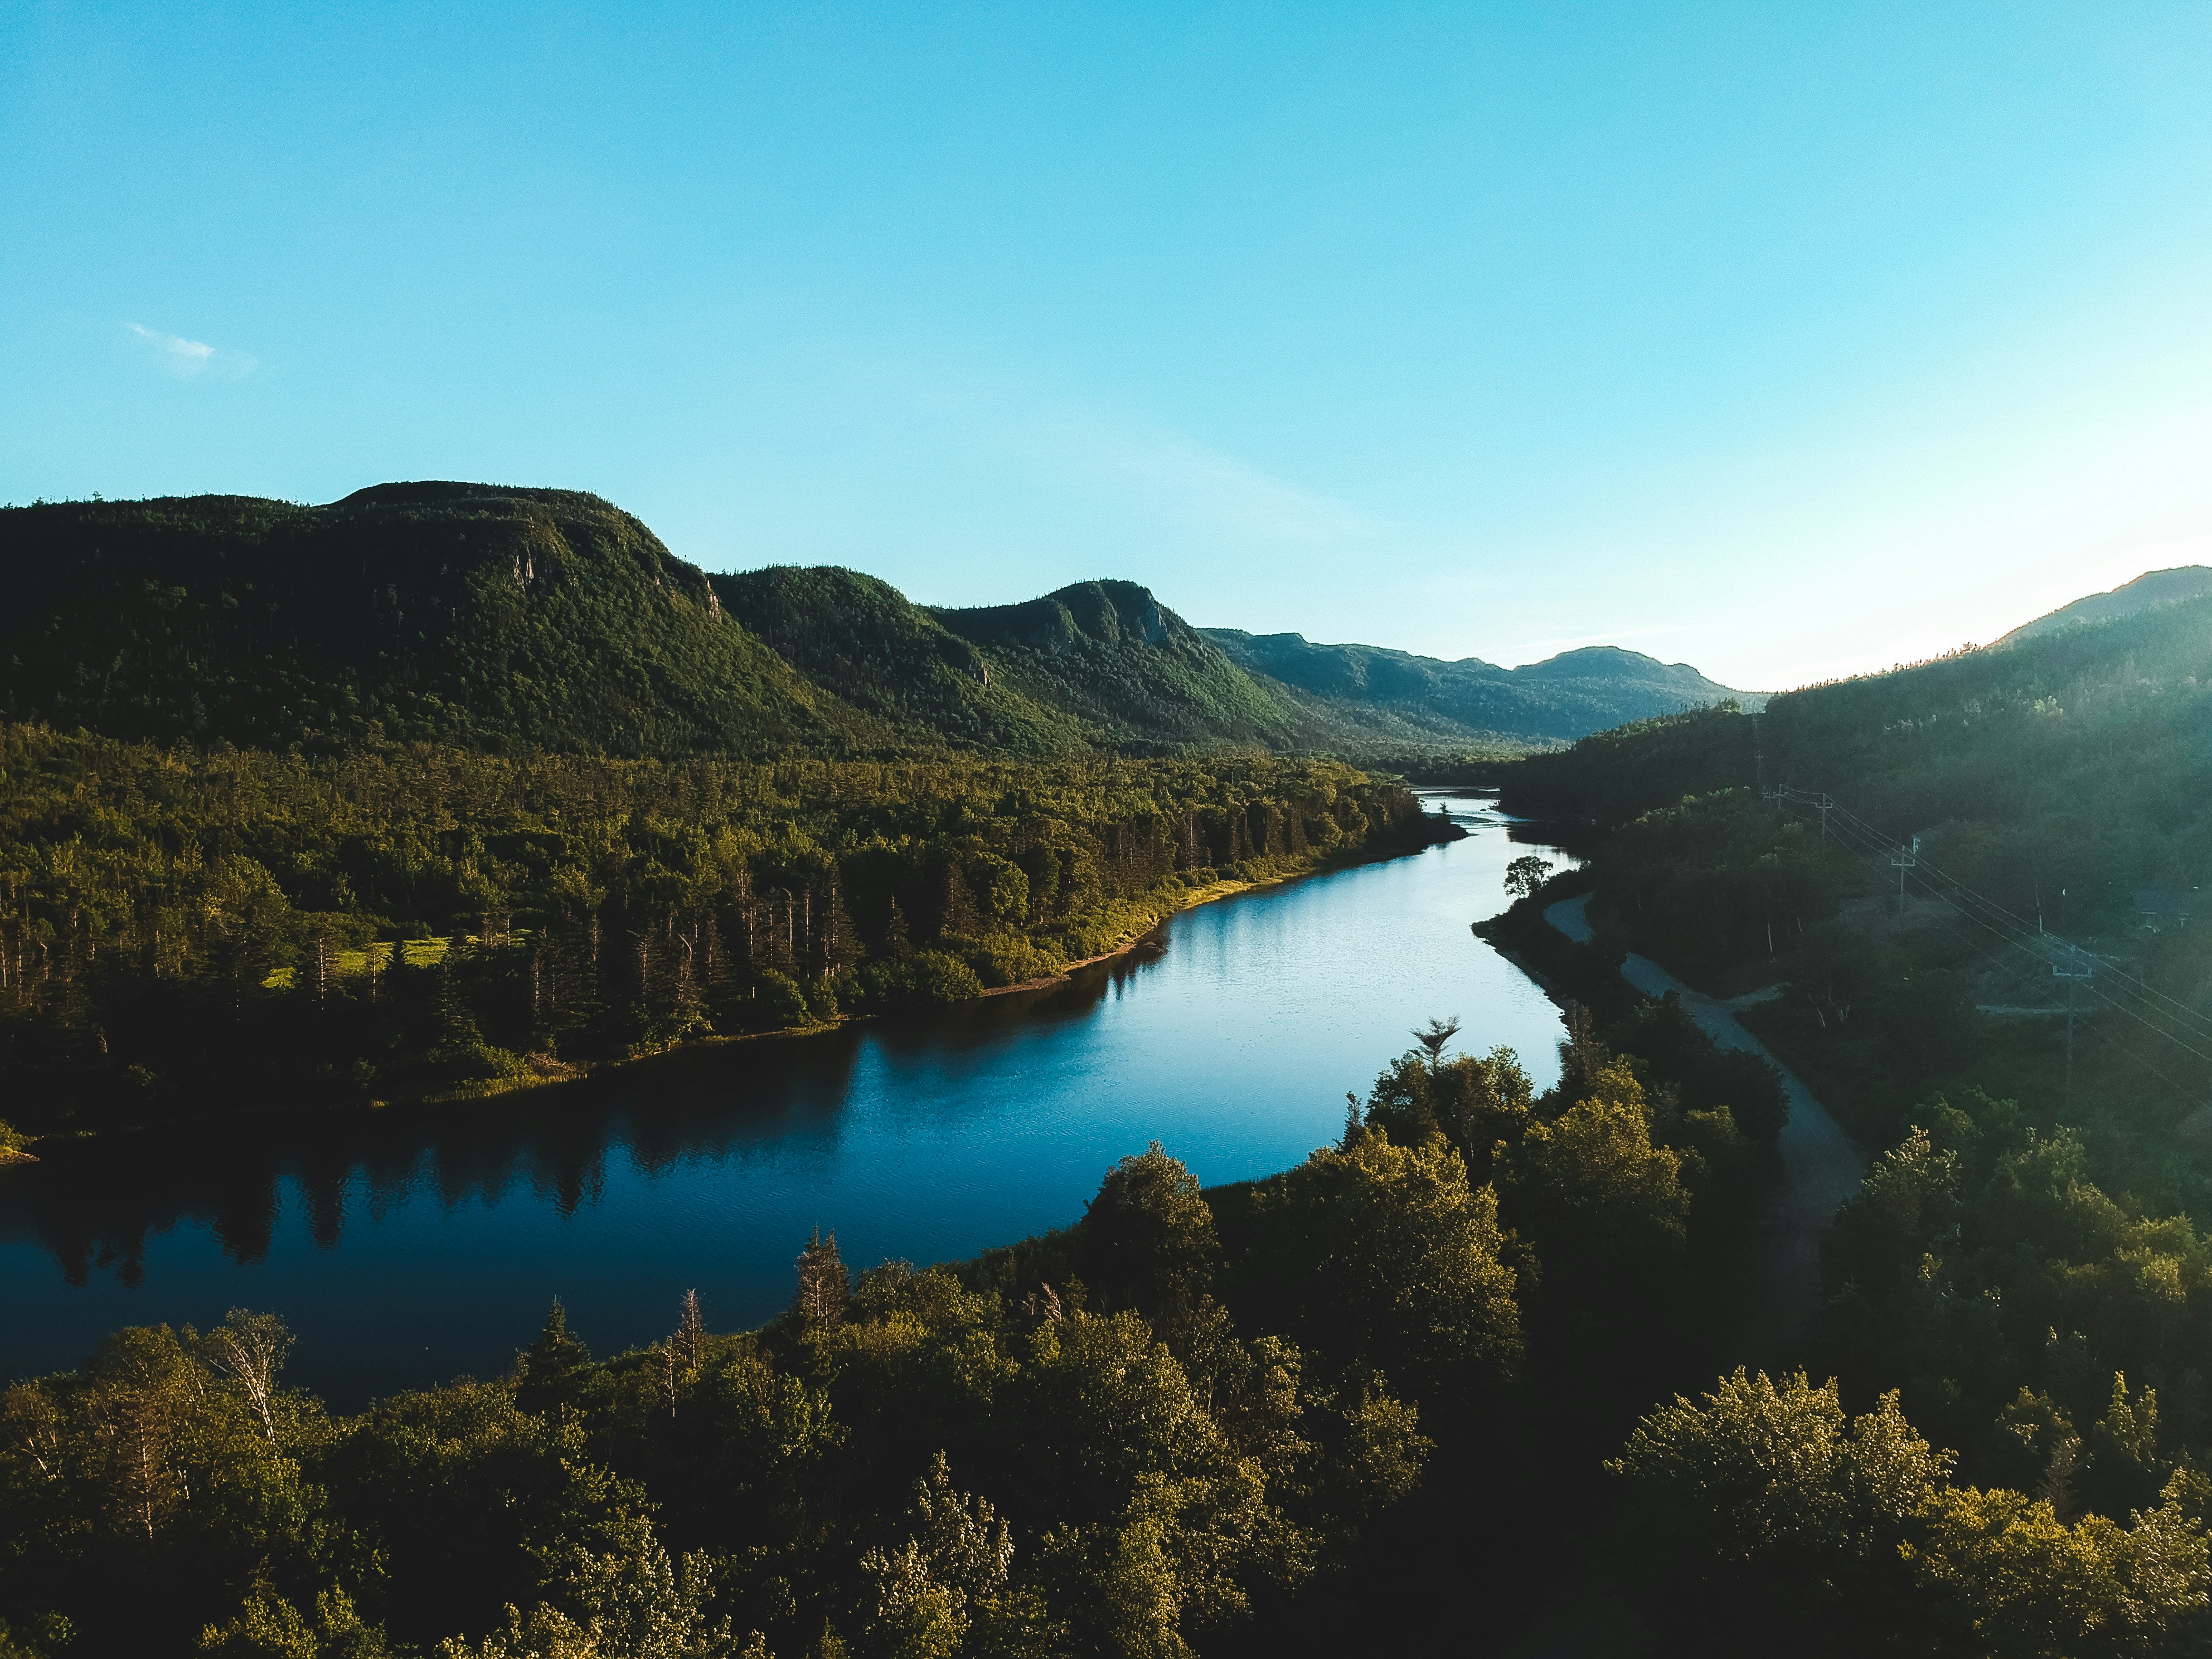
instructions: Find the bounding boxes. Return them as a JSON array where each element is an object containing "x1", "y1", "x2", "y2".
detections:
[{"x1": 0, "y1": 0, "x2": 2212, "y2": 688}]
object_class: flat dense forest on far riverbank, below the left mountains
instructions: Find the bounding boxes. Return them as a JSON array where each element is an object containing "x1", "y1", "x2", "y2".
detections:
[{"x1": 0, "y1": 726, "x2": 1456, "y2": 1133}]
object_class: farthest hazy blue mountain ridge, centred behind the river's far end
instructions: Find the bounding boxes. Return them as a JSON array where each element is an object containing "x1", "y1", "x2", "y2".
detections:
[{"x1": 1204, "y1": 628, "x2": 1759, "y2": 748}]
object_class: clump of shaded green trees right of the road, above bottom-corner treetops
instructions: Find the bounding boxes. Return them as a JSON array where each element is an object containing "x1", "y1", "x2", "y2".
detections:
[{"x1": 1823, "y1": 1090, "x2": 2212, "y2": 1515}]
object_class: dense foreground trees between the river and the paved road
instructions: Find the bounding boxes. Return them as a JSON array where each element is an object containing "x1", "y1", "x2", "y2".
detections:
[{"x1": 0, "y1": 986, "x2": 1778, "y2": 1659}]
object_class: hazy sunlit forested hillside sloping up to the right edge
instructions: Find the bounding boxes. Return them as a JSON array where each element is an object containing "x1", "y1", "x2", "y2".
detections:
[{"x1": 1506, "y1": 597, "x2": 2212, "y2": 911}]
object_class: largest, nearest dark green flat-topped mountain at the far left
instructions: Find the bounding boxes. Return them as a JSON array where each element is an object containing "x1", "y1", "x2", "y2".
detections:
[{"x1": 0, "y1": 484, "x2": 862, "y2": 754}]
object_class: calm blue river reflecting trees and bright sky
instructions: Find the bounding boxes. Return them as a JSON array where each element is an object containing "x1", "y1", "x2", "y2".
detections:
[{"x1": 0, "y1": 796, "x2": 1559, "y2": 1405}]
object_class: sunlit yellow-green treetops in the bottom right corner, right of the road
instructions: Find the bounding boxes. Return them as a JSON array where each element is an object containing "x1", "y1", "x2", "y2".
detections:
[{"x1": 1608, "y1": 1369, "x2": 2212, "y2": 1659}]
